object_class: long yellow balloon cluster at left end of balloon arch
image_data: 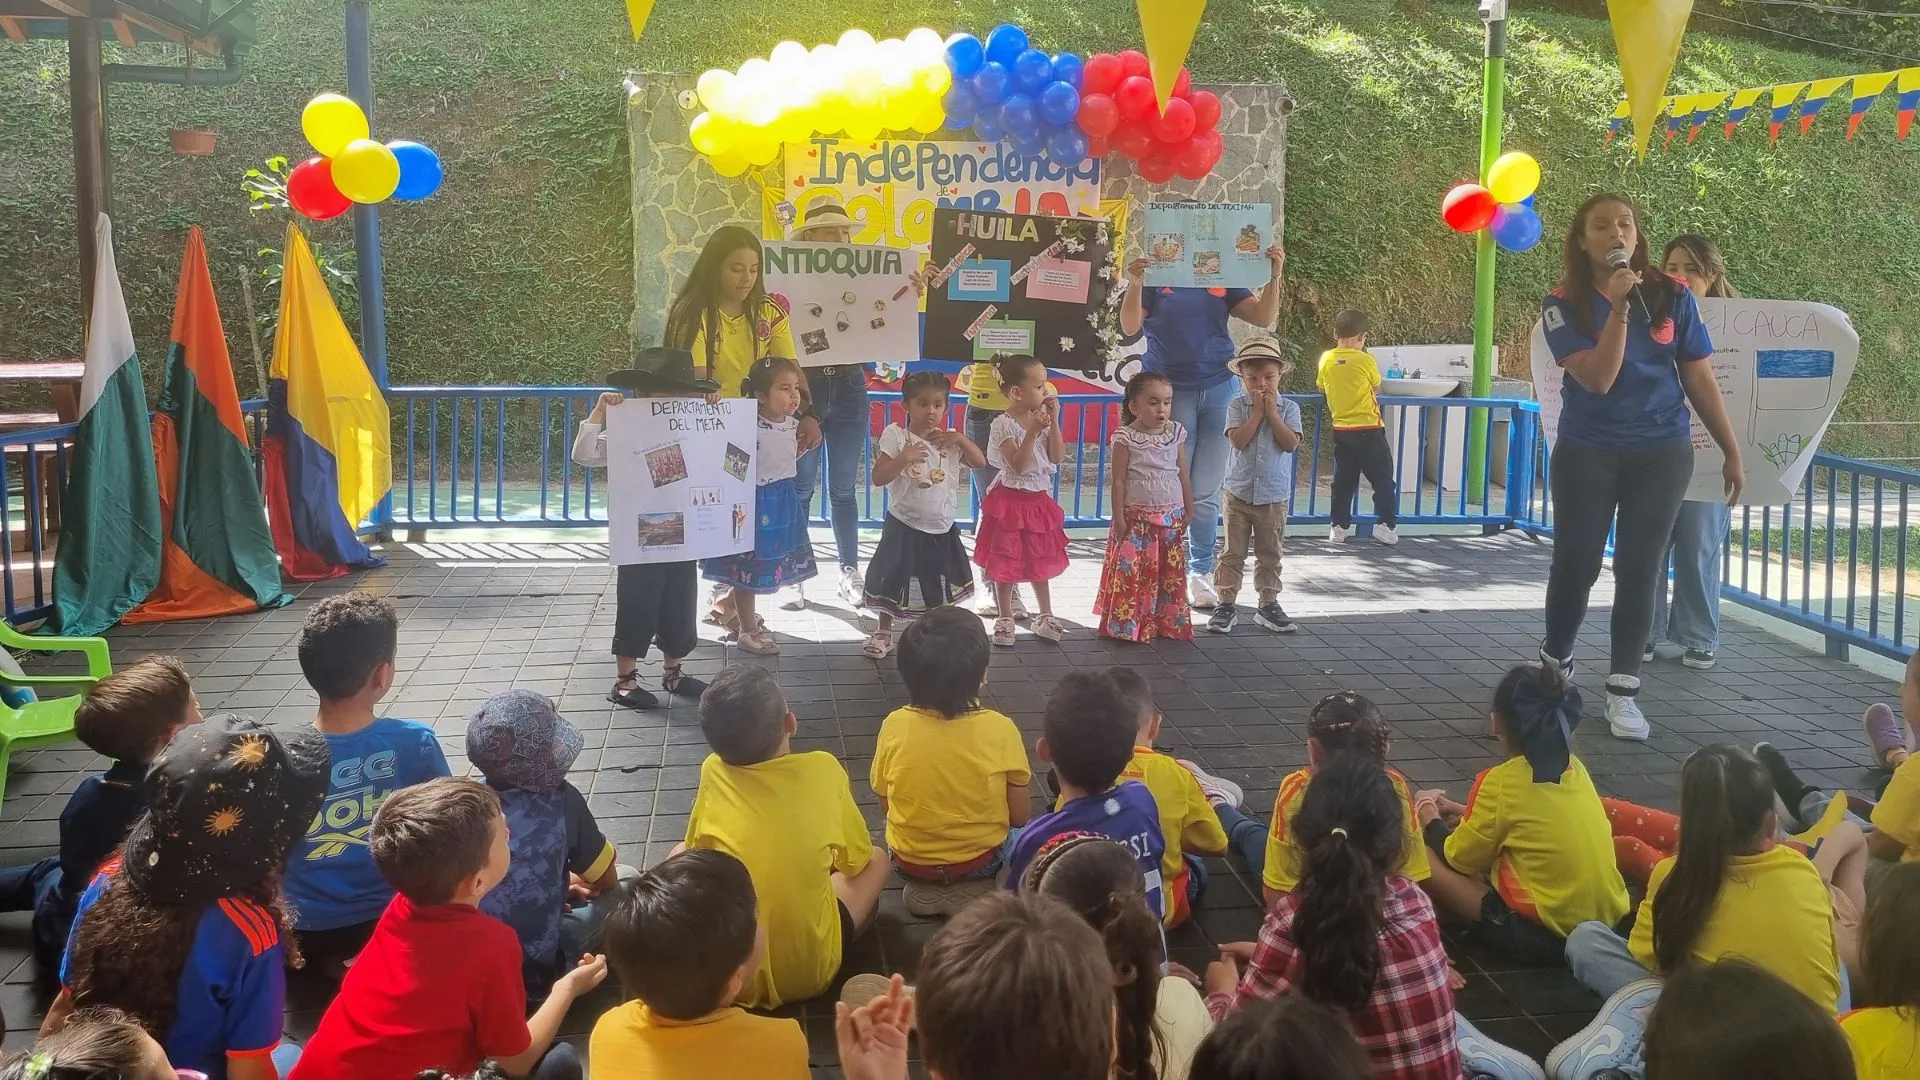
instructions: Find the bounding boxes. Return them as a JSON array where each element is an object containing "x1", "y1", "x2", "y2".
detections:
[{"x1": 687, "y1": 27, "x2": 952, "y2": 177}]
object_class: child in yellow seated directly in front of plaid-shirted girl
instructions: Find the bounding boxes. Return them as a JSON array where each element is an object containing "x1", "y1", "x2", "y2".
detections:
[{"x1": 1260, "y1": 690, "x2": 1432, "y2": 907}]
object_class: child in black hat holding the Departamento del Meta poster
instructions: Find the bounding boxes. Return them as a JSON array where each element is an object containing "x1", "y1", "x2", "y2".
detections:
[{"x1": 574, "y1": 348, "x2": 720, "y2": 709}]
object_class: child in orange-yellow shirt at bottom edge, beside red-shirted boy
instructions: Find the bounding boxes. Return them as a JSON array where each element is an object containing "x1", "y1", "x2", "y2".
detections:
[{"x1": 588, "y1": 849, "x2": 814, "y2": 1080}]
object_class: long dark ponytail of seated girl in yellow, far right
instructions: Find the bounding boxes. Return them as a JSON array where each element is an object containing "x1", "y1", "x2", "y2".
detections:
[{"x1": 1653, "y1": 744, "x2": 1774, "y2": 972}]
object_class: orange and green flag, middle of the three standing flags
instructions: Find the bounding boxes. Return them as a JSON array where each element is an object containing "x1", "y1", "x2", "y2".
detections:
[{"x1": 123, "y1": 225, "x2": 292, "y2": 623}]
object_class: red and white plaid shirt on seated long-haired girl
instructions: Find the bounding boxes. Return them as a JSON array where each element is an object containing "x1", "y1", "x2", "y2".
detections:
[{"x1": 1208, "y1": 874, "x2": 1467, "y2": 1080}]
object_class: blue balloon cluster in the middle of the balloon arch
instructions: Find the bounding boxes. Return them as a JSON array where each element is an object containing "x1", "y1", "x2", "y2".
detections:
[{"x1": 941, "y1": 23, "x2": 1090, "y2": 165}]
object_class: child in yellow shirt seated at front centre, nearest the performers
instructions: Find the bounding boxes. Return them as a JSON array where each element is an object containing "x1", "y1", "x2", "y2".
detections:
[{"x1": 870, "y1": 607, "x2": 1033, "y2": 915}]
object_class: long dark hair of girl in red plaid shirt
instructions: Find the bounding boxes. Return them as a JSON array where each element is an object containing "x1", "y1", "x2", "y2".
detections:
[{"x1": 1292, "y1": 753, "x2": 1407, "y2": 1011}]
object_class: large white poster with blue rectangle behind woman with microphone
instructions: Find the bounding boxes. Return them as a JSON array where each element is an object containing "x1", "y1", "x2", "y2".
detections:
[{"x1": 1530, "y1": 296, "x2": 1860, "y2": 505}]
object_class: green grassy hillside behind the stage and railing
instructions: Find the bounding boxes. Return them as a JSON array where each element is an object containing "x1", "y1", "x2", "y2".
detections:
[{"x1": 0, "y1": 0, "x2": 1920, "y2": 457}]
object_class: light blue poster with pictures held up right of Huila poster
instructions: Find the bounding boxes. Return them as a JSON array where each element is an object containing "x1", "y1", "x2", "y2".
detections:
[{"x1": 1146, "y1": 202, "x2": 1273, "y2": 288}]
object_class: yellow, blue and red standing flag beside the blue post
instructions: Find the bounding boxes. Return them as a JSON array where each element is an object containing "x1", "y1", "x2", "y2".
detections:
[{"x1": 265, "y1": 225, "x2": 394, "y2": 580}]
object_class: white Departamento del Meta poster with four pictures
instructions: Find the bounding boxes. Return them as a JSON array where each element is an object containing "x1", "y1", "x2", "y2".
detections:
[{"x1": 607, "y1": 398, "x2": 758, "y2": 567}]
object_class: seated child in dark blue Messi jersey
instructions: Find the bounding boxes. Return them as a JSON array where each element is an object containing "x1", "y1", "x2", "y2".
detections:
[{"x1": 1006, "y1": 671, "x2": 1167, "y2": 919}]
